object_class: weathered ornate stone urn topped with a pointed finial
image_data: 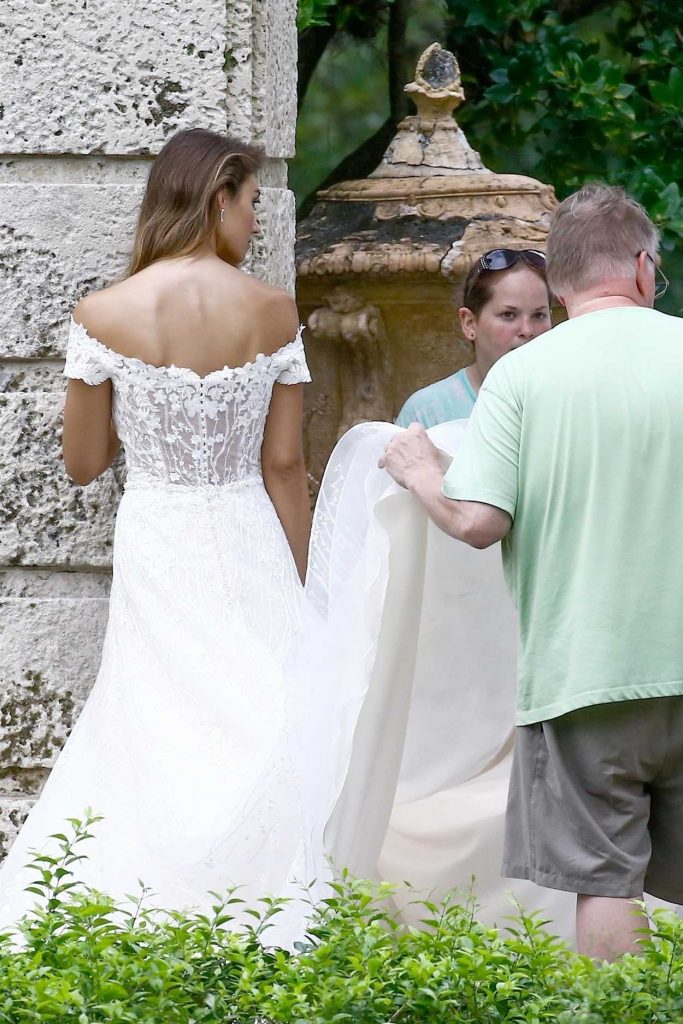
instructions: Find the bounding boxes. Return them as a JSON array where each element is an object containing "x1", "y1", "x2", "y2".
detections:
[{"x1": 296, "y1": 43, "x2": 557, "y2": 490}]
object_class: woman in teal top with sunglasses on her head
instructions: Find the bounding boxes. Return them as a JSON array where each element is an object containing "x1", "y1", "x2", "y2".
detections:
[{"x1": 396, "y1": 249, "x2": 552, "y2": 428}]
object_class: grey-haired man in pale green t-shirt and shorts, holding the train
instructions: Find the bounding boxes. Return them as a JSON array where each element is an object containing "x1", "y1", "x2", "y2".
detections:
[{"x1": 381, "y1": 185, "x2": 683, "y2": 958}]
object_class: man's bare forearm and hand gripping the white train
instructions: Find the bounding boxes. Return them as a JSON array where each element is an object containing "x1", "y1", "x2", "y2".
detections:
[{"x1": 379, "y1": 423, "x2": 512, "y2": 548}]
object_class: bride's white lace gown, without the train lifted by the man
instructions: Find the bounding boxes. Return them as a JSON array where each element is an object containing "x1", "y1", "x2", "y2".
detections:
[{"x1": 0, "y1": 322, "x2": 315, "y2": 943}]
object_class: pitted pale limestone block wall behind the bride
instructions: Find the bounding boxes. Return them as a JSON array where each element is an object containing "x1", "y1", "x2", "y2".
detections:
[{"x1": 0, "y1": 0, "x2": 296, "y2": 856}]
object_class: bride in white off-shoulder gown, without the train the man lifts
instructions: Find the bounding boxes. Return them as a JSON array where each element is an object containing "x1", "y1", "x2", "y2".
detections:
[{"x1": 0, "y1": 129, "x2": 311, "y2": 940}]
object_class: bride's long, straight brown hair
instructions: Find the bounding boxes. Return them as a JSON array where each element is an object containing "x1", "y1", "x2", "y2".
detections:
[{"x1": 127, "y1": 128, "x2": 265, "y2": 276}]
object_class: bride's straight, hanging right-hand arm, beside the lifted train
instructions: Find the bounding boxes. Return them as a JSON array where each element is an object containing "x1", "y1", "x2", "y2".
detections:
[{"x1": 261, "y1": 384, "x2": 310, "y2": 583}]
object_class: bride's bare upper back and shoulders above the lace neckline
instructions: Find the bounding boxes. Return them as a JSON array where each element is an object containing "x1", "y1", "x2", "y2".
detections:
[{"x1": 74, "y1": 254, "x2": 298, "y2": 376}]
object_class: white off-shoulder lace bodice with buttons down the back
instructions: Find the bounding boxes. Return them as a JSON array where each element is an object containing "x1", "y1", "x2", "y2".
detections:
[{"x1": 63, "y1": 319, "x2": 310, "y2": 487}]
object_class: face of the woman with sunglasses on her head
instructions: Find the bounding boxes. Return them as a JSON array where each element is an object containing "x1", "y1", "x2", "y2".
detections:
[{"x1": 460, "y1": 261, "x2": 552, "y2": 377}]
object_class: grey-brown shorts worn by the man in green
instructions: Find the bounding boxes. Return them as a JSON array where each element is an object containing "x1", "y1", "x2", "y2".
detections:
[{"x1": 503, "y1": 696, "x2": 683, "y2": 903}]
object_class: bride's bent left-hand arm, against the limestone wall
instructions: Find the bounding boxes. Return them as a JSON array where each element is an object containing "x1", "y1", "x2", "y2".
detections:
[{"x1": 61, "y1": 380, "x2": 120, "y2": 486}]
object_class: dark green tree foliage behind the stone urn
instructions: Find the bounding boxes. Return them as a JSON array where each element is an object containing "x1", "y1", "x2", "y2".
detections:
[{"x1": 299, "y1": 0, "x2": 683, "y2": 248}]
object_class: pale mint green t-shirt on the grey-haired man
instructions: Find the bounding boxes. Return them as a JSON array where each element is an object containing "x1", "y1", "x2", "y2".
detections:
[{"x1": 443, "y1": 307, "x2": 683, "y2": 725}]
